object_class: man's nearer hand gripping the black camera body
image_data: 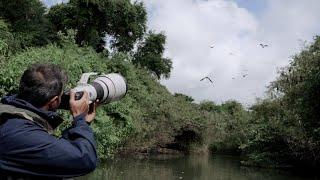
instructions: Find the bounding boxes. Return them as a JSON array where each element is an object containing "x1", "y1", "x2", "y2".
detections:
[{"x1": 69, "y1": 90, "x2": 89, "y2": 117}]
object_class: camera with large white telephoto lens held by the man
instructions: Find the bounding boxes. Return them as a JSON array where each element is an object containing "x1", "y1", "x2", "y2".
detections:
[{"x1": 59, "y1": 72, "x2": 127, "y2": 110}]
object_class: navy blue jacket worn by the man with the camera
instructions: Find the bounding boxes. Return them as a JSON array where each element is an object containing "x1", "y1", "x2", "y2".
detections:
[{"x1": 0, "y1": 96, "x2": 97, "y2": 179}]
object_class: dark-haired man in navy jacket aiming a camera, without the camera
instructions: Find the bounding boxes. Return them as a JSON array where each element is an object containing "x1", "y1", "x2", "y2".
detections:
[{"x1": 0, "y1": 64, "x2": 97, "y2": 180}]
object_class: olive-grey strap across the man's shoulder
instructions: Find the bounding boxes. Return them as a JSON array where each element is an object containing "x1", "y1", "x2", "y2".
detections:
[{"x1": 0, "y1": 103, "x2": 53, "y2": 134}]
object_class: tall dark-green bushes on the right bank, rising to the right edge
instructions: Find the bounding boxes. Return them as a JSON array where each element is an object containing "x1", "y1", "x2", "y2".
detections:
[{"x1": 242, "y1": 36, "x2": 320, "y2": 166}]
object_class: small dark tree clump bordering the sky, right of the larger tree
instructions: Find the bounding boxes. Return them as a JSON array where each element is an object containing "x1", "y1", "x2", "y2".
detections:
[{"x1": 133, "y1": 32, "x2": 172, "y2": 79}]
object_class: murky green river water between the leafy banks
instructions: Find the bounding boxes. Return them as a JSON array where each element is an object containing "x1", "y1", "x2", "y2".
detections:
[{"x1": 77, "y1": 155, "x2": 318, "y2": 180}]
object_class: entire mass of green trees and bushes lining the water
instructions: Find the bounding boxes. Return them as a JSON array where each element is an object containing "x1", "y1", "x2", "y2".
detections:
[{"x1": 0, "y1": 0, "x2": 320, "y2": 167}]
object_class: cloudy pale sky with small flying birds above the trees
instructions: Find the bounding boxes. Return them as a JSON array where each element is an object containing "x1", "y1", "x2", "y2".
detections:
[{"x1": 45, "y1": 0, "x2": 320, "y2": 104}]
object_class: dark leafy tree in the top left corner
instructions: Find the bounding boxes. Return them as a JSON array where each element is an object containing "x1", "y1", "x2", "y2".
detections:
[{"x1": 0, "y1": 0, "x2": 55, "y2": 48}]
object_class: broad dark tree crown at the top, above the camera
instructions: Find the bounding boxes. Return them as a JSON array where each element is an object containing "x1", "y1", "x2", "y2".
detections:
[{"x1": 47, "y1": 0, "x2": 147, "y2": 52}]
